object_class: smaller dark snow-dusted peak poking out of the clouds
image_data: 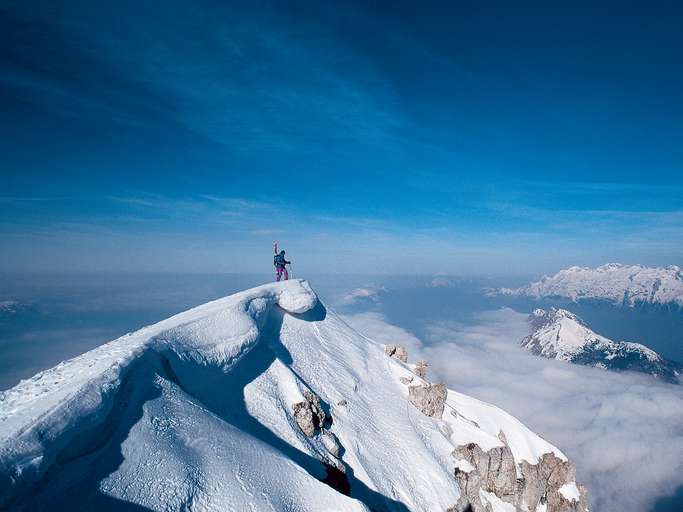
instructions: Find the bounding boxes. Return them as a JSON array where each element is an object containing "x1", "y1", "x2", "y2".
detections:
[{"x1": 522, "y1": 308, "x2": 683, "y2": 383}]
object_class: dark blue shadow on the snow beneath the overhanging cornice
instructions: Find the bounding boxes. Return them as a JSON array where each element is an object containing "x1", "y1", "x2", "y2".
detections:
[{"x1": 18, "y1": 303, "x2": 408, "y2": 512}]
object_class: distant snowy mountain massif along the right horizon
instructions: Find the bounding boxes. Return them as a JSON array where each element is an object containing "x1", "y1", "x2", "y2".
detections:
[{"x1": 497, "y1": 263, "x2": 683, "y2": 307}]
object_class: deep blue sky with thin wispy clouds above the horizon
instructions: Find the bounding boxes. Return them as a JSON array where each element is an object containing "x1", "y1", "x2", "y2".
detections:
[{"x1": 0, "y1": 0, "x2": 683, "y2": 274}]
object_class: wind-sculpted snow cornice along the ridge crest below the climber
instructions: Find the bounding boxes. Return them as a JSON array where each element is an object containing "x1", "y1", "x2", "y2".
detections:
[{"x1": 0, "y1": 281, "x2": 332, "y2": 506}]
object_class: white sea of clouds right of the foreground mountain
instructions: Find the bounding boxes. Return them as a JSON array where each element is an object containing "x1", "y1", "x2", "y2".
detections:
[{"x1": 345, "y1": 308, "x2": 683, "y2": 512}]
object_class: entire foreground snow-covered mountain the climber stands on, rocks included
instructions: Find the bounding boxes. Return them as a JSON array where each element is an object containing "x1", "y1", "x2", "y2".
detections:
[{"x1": 0, "y1": 280, "x2": 587, "y2": 512}]
